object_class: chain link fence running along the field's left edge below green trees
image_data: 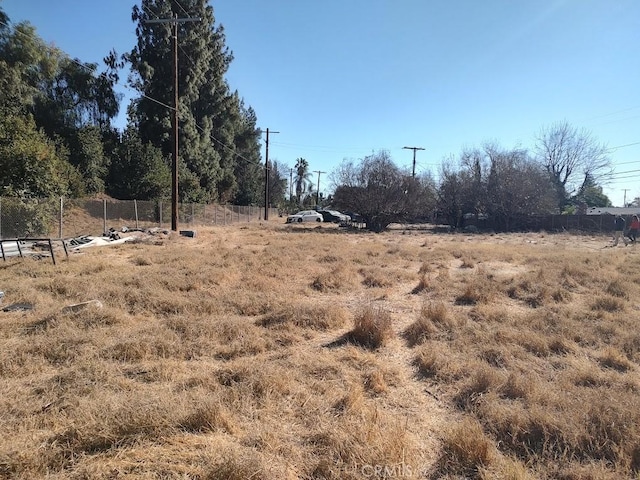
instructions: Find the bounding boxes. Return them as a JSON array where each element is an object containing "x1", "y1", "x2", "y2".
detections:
[{"x1": 0, "y1": 197, "x2": 278, "y2": 239}]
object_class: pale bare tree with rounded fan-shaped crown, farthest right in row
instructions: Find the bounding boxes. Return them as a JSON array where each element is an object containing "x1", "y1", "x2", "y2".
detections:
[{"x1": 535, "y1": 122, "x2": 611, "y2": 209}]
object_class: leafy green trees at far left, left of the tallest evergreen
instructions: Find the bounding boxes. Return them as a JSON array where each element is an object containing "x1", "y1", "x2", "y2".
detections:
[{"x1": 0, "y1": 15, "x2": 119, "y2": 197}]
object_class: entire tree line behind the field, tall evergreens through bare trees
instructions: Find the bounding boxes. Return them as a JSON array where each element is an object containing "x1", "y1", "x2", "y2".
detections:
[{"x1": 0, "y1": 0, "x2": 611, "y2": 231}]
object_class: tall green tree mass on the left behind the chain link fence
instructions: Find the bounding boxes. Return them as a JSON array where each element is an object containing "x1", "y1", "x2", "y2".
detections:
[{"x1": 0, "y1": 0, "x2": 264, "y2": 205}]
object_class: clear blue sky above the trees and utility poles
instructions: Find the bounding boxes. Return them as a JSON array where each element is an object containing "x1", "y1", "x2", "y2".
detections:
[{"x1": 0, "y1": 0, "x2": 640, "y2": 206}]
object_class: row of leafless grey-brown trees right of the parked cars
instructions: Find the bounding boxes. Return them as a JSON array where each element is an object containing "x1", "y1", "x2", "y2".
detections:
[{"x1": 332, "y1": 126, "x2": 611, "y2": 231}]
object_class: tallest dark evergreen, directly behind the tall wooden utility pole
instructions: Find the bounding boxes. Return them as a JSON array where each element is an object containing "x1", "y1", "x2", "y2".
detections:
[{"x1": 127, "y1": 0, "x2": 259, "y2": 201}]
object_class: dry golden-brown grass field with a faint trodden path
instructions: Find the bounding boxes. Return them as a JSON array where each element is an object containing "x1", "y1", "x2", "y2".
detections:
[{"x1": 0, "y1": 220, "x2": 640, "y2": 480}]
